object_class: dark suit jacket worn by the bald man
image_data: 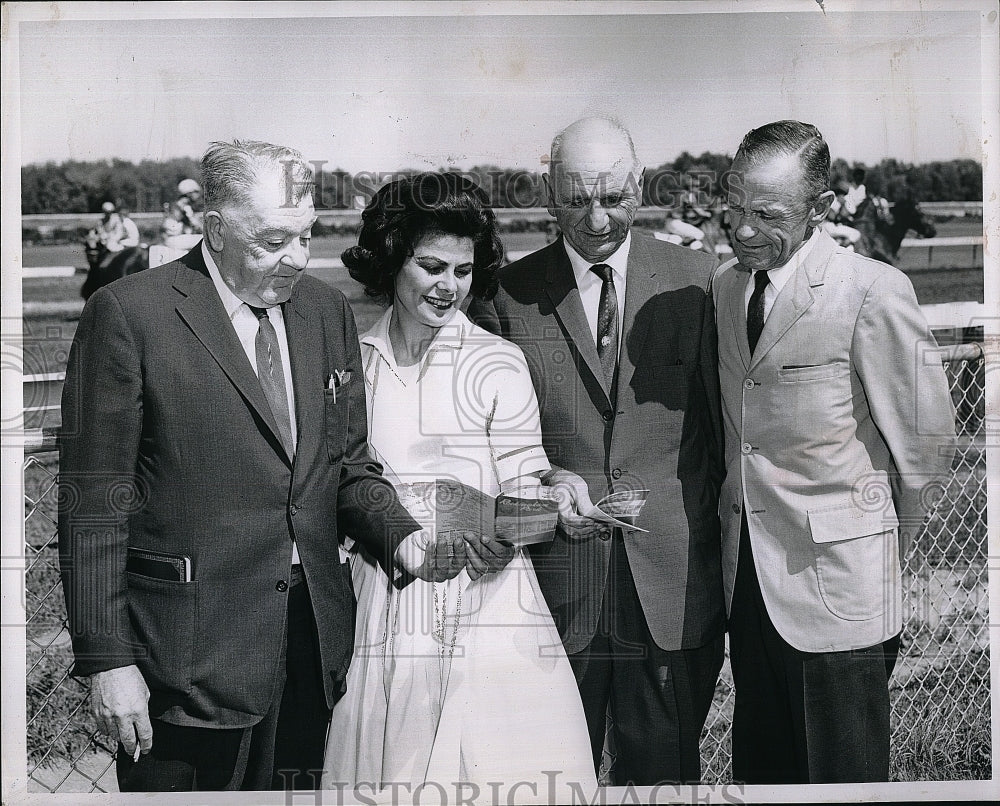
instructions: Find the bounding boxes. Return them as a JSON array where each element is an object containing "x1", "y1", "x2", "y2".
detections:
[{"x1": 470, "y1": 234, "x2": 724, "y2": 653}]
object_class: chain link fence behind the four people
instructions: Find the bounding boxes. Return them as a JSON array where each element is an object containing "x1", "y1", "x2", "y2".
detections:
[{"x1": 24, "y1": 345, "x2": 991, "y2": 793}]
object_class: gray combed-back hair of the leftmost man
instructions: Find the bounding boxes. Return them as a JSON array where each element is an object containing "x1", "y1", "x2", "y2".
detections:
[{"x1": 201, "y1": 140, "x2": 313, "y2": 210}]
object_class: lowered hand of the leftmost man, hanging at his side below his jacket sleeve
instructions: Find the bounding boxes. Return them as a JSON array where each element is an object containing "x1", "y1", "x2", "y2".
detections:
[{"x1": 90, "y1": 666, "x2": 153, "y2": 756}]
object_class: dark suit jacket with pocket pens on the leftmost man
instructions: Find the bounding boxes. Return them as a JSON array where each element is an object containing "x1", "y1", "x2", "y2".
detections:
[{"x1": 59, "y1": 245, "x2": 418, "y2": 727}]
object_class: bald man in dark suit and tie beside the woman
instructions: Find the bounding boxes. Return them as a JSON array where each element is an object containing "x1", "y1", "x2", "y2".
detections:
[{"x1": 472, "y1": 118, "x2": 724, "y2": 785}]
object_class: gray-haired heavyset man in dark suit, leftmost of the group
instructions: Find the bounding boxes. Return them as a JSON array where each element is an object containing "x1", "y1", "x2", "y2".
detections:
[{"x1": 59, "y1": 142, "x2": 468, "y2": 791}]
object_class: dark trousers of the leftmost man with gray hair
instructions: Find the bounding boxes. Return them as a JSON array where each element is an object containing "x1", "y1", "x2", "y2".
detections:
[{"x1": 117, "y1": 566, "x2": 330, "y2": 792}]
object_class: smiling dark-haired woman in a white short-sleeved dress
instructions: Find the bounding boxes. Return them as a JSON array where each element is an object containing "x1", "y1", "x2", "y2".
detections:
[{"x1": 324, "y1": 174, "x2": 596, "y2": 802}]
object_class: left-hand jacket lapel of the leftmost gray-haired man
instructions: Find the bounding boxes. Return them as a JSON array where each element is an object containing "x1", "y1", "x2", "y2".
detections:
[{"x1": 174, "y1": 251, "x2": 291, "y2": 464}]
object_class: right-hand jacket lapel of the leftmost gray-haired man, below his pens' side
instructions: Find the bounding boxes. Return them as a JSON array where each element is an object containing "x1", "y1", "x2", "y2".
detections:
[{"x1": 283, "y1": 289, "x2": 326, "y2": 476}]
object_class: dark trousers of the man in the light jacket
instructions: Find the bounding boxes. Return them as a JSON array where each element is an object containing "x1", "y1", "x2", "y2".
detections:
[{"x1": 729, "y1": 518, "x2": 899, "y2": 784}]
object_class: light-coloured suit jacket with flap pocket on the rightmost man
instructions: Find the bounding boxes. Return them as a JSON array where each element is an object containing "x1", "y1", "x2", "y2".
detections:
[{"x1": 714, "y1": 232, "x2": 955, "y2": 652}]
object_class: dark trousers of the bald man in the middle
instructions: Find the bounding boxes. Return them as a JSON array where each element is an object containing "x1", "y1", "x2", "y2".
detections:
[{"x1": 569, "y1": 534, "x2": 724, "y2": 786}]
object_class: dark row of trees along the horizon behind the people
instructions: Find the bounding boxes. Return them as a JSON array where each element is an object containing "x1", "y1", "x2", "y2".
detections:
[{"x1": 21, "y1": 151, "x2": 983, "y2": 215}]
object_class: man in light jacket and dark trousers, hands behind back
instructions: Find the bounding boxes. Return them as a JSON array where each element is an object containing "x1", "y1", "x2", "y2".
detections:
[{"x1": 714, "y1": 121, "x2": 955, "y2": 783}]
